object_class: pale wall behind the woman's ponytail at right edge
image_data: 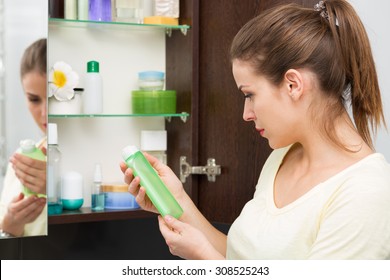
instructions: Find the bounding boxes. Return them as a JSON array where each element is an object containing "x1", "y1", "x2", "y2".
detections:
[{"x1": 350, "y1": 0, "x2": 390, "y2": 162}]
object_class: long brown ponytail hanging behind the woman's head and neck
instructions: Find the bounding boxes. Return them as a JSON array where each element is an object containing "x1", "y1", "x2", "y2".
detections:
[{"x1": 324, "y1": 0, "x2": 386, "y2": 147}]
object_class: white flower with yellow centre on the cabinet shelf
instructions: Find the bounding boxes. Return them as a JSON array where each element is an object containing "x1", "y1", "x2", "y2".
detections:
[{"x1": 49, "y1": 61, "x2": 79, "y2": 101}]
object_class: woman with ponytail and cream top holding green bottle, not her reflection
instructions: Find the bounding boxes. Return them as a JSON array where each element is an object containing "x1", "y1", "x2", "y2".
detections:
[{"x1": 122, "y1": 0, "x2": 390, "y2": 259}]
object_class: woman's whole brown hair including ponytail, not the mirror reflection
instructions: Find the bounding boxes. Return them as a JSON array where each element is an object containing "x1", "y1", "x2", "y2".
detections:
[{"x1": 230, "y1": 0, "x2": 386, "y2": 150}]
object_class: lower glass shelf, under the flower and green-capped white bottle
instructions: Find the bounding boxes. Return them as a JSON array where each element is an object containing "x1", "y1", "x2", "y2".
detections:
[{"x1": 48, "y1": 112, "x2": 190, "y2": 122}]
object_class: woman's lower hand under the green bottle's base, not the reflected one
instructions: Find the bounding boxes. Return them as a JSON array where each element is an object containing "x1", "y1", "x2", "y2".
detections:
[{"x1": 158, "y1": 215, "x2": 224, "y2": 260}]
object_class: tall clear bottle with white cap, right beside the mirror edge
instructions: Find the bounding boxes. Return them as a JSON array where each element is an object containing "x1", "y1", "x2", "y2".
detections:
[{"x1": 47, "y1": 123, "x2": 62, "y2": 215}]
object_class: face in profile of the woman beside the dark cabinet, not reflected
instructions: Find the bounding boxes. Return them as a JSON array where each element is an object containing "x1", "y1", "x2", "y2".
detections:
[{"x1": 233, "y1": 60, "x2": 299, "y2": 149}]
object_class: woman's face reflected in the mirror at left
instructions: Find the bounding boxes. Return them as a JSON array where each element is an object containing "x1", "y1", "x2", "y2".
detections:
[{"x1": 22, "y1": 71, "x2": 47, "y2": 133}]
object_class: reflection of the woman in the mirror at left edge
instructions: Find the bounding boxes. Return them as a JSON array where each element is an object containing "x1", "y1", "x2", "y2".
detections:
[{"x1": 0, "y1": 39, "x2": 47, "y2": 237}]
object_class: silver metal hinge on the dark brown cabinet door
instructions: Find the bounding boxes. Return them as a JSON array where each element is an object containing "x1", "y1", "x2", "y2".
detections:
[{"x1": 180, "y1": 156, "x2": 221, "y2": 183}]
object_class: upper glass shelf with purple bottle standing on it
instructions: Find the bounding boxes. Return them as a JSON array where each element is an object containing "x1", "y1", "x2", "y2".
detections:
[{"x1": 49, "y1": 18, "x2": 190, "y2": 36}]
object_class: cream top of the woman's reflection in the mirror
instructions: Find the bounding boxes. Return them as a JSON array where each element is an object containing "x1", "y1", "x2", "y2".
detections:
[{"x1": 0, "y1": 139, "x2": 47, "y2": 236}]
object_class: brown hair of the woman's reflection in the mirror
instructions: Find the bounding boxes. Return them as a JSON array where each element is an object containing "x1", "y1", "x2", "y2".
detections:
[{"x1": 20, "y1": 39, "x2": 47, "y2": 78}]
